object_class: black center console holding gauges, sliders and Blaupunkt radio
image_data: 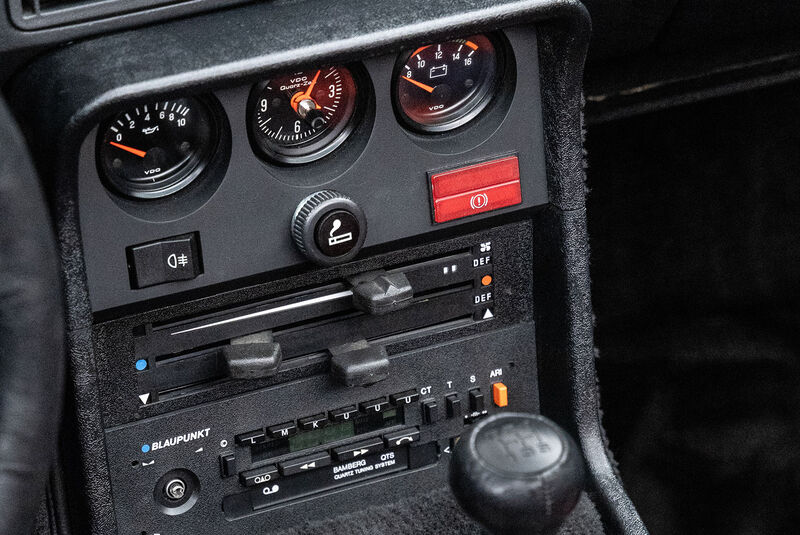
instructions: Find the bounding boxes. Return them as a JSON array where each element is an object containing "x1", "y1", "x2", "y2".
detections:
[{"x1": 7, "y1": 0, "x2": 648, "y2": 535}]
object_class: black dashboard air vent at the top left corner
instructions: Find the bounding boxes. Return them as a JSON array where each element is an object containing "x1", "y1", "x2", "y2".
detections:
[{"x1": 8, "y1": 0, "x2": 242, "y2": 30}]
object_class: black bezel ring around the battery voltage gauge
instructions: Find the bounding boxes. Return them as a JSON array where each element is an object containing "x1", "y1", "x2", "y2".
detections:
[{"x1": 391, "y1": 32, "x2": 508, "y2": 134}]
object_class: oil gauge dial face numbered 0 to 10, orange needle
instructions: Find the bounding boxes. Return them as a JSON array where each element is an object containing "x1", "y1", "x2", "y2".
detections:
[{"x1": 97, "y1": 98, "x2": 218, "y2": 199}]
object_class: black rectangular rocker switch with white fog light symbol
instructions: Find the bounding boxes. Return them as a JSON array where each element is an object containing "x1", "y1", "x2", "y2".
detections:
[{"x1": 127, "y1": 233, "x2": 203, "y2": 289}]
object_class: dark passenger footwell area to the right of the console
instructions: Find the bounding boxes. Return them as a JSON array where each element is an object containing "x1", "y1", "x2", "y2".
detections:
[{"x1": 588, "y1": 77, "x2": 800, "y2": 535}]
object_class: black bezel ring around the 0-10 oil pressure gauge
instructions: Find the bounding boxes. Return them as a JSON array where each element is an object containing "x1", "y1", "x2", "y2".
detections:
[{"x1": 95, "y1": 95, "x2": 223, "y2": 201}]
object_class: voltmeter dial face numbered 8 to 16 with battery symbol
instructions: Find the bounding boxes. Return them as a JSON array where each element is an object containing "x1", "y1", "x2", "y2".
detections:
[{"x1": 394, "y1": 35, "x2": 498, "y2": 132}]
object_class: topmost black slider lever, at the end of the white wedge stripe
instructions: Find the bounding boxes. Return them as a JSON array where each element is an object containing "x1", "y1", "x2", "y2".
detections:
[{"x1": 347, "y1": 270, "x2": 414, "y2": 316}]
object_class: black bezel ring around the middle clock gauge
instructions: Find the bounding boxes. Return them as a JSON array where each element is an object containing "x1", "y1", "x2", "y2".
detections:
[{"x1": 245, "y1": 63, "x2": 369, "y2": 165}]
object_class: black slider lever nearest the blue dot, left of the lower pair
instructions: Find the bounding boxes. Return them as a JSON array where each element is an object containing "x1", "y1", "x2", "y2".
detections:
[{"x1": 222, "y1": 331, "x2": 283, "y2": 379}]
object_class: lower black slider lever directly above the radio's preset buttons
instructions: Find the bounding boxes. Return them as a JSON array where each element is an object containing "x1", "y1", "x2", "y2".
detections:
[{"x1": 328, "y1": 340, "x2": 389, "y2": 386}]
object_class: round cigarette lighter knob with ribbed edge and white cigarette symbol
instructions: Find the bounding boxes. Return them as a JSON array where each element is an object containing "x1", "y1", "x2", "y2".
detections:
[{"x1": 292, "y1": 190, "x2": 367, "y2": 266}]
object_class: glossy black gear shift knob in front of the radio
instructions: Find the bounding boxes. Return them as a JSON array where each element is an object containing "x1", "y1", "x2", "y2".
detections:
[{"x1": 450, "y1": 413, "x2": 583, "y2": 535}]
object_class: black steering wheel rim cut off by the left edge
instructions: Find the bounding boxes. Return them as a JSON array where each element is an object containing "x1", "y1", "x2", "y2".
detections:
[{"x1": 0, "y1": 100, "x2": 65, "y2": 535}]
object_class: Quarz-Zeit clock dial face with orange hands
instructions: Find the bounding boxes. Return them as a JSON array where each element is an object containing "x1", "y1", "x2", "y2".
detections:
[{"x1": 249, "y1": 66, "x2": 358, "y2": 164}]
